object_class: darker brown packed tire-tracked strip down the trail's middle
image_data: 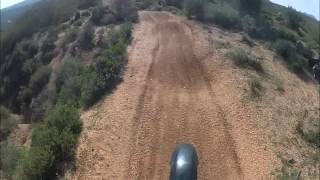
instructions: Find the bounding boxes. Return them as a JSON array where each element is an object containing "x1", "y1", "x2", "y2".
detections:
[{"x1": 128, "y1": 13, "x2": 241, "y2": 179}]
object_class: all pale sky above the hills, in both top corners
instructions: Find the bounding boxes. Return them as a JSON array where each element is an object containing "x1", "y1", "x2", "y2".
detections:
[{"x1": 0, "y1": 0, "x2": 320, "y2": 20}]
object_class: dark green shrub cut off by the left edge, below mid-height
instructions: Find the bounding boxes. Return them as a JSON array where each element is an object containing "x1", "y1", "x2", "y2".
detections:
[{"x1": 0, "y1": 105, "x2": 17, "y2": 141}]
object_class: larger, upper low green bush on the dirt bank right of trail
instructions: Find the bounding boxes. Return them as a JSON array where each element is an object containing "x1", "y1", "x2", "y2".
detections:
[{"x1": 230, "y1": 49, "x2": 264, "y2": 73}]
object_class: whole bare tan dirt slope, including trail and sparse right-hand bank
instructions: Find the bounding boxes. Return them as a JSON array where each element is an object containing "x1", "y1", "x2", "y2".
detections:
[{"x1": 74, "y1": 12, "x2": 319, "y2": 179}]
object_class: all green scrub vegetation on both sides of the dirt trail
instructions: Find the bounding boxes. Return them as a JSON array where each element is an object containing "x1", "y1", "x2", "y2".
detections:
[{"x1": 0, "y1": 0, "x2": 320, "y2": 179}]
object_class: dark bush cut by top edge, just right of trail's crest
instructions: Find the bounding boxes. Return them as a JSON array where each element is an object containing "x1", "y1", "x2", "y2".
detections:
[{"x1": 184, "y1": 0, "x2": 206, "y2": 20}]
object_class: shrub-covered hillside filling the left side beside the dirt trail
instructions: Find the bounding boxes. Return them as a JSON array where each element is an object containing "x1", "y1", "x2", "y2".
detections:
[{"x1": 0, "y1": 0, "x2": 137, "y2": 179}]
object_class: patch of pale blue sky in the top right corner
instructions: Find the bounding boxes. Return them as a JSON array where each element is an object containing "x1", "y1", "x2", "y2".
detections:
[{"x1": 271, "y1": 0, "x2": 320, "y2": 20}]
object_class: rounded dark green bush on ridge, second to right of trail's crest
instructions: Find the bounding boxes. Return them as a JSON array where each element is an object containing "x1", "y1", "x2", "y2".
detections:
[{"x1": 204, "y1": 3, "x2": 241, "y2": 29}]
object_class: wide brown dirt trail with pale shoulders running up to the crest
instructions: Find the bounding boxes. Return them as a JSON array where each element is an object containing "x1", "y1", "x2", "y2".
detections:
[{"x1": 74, "y1": 12, "x2": 273, "y2": 180}]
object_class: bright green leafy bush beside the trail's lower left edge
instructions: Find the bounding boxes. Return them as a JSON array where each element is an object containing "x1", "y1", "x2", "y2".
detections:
[{"x1": 32, "y1": 105, "x2": 82, "y2": 158}]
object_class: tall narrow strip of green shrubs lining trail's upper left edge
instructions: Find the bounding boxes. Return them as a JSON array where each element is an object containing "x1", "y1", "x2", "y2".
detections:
[{"x1": 81, "y1": 23, "x2": 132, "y2": 107}]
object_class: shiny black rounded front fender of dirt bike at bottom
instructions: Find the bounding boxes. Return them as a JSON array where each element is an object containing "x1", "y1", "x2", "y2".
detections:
[{"x1": 170, "y1": 144, "x2": 198, "y2": 180}]
